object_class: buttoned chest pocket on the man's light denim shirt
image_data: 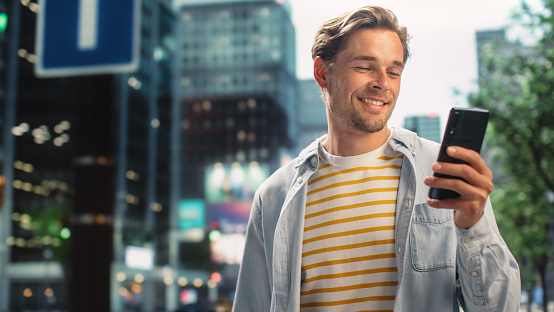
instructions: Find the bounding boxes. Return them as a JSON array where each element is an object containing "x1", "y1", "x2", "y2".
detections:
[{"x1": 410, "y1": 204, "x2": 457, "y2": 271}]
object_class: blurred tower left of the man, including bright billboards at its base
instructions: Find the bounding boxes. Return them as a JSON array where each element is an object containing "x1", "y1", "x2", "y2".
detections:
[{"x1": 174, "y1": 0, "x2": 299, "y2": 303}]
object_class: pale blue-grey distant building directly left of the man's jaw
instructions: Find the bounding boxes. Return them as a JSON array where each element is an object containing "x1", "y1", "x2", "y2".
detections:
[{"x1": 297, "y1": 79, "x2": 327, "y2": 153}]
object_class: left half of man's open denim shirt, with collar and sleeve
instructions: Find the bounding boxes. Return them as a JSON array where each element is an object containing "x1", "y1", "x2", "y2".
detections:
[{"x1": 233, "y1": 139, "x2": 320, "y2": 312}]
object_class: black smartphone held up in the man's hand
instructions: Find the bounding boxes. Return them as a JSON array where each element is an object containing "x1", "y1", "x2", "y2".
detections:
[{"x1": 429, "y1": 107, "x2": 490, "y2": 199}]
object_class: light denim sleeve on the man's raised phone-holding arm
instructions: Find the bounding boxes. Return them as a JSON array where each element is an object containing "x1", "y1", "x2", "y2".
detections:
[{"x1": 457, "y1": 200, "x2": 521, "y2": 312}]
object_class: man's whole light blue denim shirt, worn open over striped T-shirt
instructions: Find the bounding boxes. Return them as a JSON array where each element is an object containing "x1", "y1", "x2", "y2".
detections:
[{"x1": 233, "y1": 128, "x2": 521, "y2": 312}]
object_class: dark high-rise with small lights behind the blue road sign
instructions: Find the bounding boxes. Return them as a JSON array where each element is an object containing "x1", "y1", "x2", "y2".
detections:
[{"x1": 0, "y1": 0, "x2": 185, "y2": 311}]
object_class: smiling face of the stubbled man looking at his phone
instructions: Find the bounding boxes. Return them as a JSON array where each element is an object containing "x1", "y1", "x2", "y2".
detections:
[{"x1": 326, "y1": 28, "x2": 404, "y2": 133}]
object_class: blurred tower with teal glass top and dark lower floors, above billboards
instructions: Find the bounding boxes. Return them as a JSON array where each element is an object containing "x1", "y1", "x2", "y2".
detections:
[{"x1": 177, "y1": 0, "x2": 297, "y2": 178}]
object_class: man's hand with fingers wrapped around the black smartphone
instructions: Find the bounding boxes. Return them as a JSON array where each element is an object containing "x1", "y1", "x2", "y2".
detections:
[{"x1": 424, "y1": 146, "x2": 494, "y2": 229}]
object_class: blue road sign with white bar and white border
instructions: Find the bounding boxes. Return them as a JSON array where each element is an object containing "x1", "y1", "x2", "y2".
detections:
[{"x1": 35, "y1": 0, "x2": 140, "y2": 77}]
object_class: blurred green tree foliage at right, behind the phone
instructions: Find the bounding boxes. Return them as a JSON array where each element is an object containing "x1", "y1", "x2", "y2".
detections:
[{"x1": 469, "y1": 0, "x2": 554, "y2": 306}]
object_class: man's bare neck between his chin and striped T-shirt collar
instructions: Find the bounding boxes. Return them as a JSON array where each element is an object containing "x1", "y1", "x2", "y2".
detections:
[{"x1": 322, "y1": 126, "x2": 391, "y2": 156}]
